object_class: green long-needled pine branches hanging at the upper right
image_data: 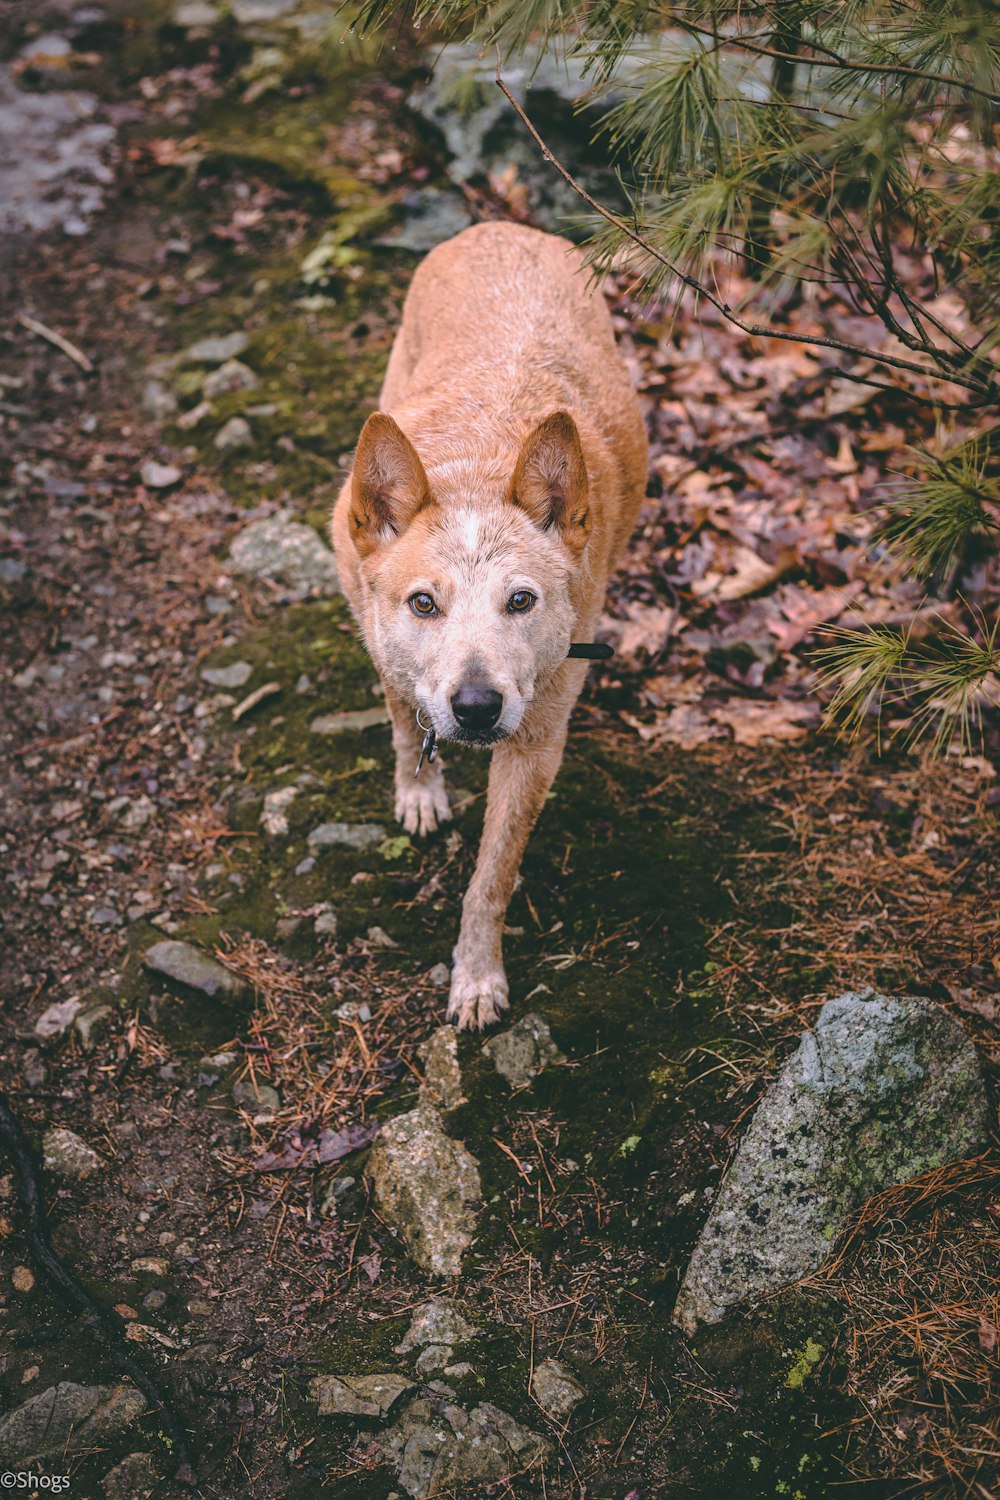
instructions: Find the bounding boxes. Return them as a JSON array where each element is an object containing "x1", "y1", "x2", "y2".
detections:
[{"x1": 360, "y1": 0, "x2": 1000, "y2": 747}]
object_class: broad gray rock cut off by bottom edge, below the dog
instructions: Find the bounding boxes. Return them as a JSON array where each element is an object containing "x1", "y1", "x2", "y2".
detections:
[{"x1": 378, "y1": 1397, "x2": 550, "y2": 1500}]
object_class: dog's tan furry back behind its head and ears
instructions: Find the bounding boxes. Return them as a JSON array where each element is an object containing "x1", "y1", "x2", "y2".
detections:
[{"x1": 374, "y1": 224, "x2": 646, "y2": 572}]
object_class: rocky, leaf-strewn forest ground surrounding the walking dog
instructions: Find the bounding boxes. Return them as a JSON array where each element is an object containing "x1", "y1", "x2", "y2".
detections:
[{"x1": 0, "y1": 0, "x2": 1000, "y2": 1500}]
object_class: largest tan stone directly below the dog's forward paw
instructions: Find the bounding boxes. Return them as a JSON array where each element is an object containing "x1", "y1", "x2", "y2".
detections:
[{"x1": 367, "y1": 1104, "x2": 483, "y2": 1277}]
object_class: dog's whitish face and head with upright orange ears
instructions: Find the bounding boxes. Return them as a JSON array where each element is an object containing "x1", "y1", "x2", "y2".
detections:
[{"x1": 351, "y1": 411, "x2": 591, "y2": 746}]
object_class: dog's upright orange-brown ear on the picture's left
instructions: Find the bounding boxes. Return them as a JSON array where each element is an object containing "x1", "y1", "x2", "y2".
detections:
[{"x1": 351, "y1": 411, "x2": 430, "y2": 558}]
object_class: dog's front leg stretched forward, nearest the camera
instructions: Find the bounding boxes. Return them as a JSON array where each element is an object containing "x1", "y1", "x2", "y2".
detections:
[{"x1": 448, "y1": 723, "x2": 568, "y2": 1029}]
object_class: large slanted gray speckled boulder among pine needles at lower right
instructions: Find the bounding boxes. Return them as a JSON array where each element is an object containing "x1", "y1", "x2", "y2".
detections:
[{"x1": 673, "y1": 992, "x2": 988, "y2": 1332}]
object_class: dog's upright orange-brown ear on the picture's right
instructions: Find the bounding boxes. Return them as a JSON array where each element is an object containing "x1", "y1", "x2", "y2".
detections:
[{"x1": 508, "y1": 411, "x2": 591, "y2": 552}]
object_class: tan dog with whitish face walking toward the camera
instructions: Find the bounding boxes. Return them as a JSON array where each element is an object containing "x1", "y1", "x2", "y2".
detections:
[{"x1": 333, "y1": 224, "x2": 646, "y2": 1026}]
